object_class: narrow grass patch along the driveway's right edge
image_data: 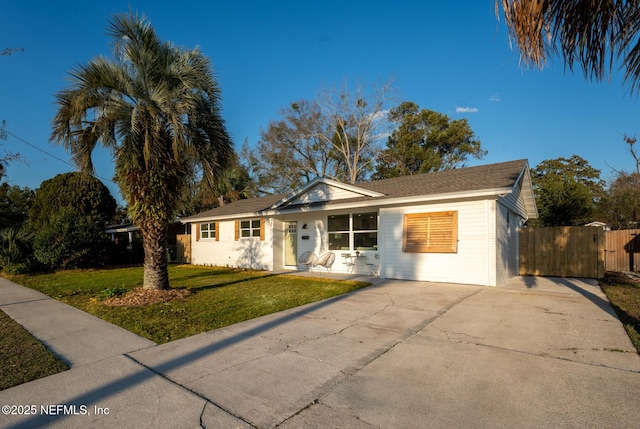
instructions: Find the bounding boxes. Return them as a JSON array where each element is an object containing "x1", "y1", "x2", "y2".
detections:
[{"x1": 600, "y1": 272, "x2": 640, "y2": 353}]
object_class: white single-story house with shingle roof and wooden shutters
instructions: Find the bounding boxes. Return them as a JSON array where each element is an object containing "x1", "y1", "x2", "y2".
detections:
[{"x1": 182, "y1": 160, "x2": 537, "y2": 286}]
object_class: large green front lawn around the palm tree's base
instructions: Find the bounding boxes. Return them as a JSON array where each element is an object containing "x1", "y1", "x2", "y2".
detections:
[{"x1": 7, "y1": 265, "x2": 369, "y2": 343}]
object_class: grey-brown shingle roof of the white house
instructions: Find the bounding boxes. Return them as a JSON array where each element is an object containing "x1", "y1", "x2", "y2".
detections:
[{"x1": 182, "y1": 159, "x2": 528, "y2": 222}]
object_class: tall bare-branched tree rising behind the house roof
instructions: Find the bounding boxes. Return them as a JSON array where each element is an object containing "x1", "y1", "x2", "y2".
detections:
[{"x1": 248, "y1": 81, "x2": 394, "y2": 193}]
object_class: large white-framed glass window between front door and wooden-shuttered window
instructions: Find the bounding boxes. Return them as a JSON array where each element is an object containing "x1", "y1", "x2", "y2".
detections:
[{"x1": 327, "y1": 212, "x2": 378, "y2": 251}]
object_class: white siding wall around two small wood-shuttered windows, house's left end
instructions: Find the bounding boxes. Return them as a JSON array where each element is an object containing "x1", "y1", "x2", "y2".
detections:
[{"x1": 191, "y1": 219, "x2": 273, "y2": 270}]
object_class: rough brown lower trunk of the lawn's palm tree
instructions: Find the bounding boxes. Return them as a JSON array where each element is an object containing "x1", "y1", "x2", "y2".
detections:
[{"x1": 140, "y1": 223, "x2": 169, "y2": 290}]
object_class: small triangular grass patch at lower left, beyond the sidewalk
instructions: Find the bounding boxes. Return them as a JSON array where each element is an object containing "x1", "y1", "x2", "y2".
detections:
[{"x1": 0, "y1": 311, "x2": 68, "y2": 390}]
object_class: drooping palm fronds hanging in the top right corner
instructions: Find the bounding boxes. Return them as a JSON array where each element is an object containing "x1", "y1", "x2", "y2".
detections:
[{"x1": 496, "y1": 0, "x2": 640, "y2": 92}]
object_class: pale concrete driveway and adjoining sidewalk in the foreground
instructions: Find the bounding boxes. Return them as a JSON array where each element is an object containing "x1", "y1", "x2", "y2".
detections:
[{"x1": 0, "y1": 277, "x2": 640, "y2": 428}]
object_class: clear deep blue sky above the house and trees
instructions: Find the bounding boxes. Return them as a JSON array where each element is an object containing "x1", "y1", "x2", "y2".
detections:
[{"x1": 0, "y1": 0, "x2": 640, "y2": 200}]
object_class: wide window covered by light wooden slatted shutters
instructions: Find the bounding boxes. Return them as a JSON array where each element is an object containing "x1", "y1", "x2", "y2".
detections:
[{"x1": 402, "y1": 211, "x2": 458, "y2": 253}]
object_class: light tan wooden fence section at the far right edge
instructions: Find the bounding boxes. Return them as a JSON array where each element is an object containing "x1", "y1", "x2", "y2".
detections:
[{"x1": 604, "y1": 229, "x2": 640, "y2": 271}]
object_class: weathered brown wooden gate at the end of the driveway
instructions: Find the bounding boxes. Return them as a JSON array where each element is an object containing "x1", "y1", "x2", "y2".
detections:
[{"x1": 519, "y1": 226, "x2": 605, "y2": 278}]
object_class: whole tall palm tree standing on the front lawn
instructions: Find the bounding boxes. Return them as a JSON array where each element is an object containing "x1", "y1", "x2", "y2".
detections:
[{"x1": 51, "y1": 14, "x2": 233, "y2": 289}]
